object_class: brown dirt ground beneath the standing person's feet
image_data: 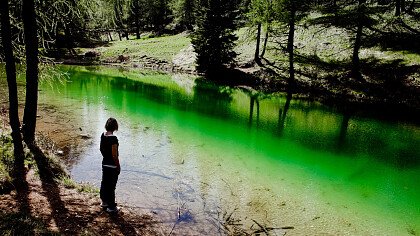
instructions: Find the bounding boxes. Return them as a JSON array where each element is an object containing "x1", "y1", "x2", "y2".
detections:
[{"x1": 0, "y1": 169, "x2": 159, "y2": 235}]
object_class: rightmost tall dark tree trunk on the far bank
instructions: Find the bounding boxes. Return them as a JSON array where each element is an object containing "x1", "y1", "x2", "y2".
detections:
[{"x1": 352, "y1": 0, "x2": 364, "y2": 80}]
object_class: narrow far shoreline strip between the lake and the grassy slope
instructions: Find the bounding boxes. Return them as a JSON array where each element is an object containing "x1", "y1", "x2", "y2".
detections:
[{"x1": 57, "y1": 57, "x2": 420, "y2": 125}]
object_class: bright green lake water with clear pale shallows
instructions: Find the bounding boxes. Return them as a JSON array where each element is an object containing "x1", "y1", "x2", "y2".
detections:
[{"x1": 34, "y1": 67, "x2": 420, "y2": 235}]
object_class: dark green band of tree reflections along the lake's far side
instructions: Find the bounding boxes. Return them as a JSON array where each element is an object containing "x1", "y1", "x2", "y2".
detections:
[{"x1": 45, "y1": 67, "x2": 420, "y2": 168}]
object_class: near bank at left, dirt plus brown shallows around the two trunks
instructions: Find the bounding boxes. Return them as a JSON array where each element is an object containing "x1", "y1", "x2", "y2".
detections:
[{"x1": 0, "y1": 86, "x2": 165, "y2": 235}]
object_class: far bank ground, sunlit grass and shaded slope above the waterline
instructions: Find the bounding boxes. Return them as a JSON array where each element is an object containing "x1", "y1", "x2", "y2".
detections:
[{"x1": 57, "y1": 28, "x2": 420, "y2": 120}]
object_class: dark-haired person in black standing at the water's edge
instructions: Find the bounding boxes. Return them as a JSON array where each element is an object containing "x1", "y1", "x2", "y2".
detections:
[{"x1": 100, "y1": 118, "x2": 121, "y2": 213}]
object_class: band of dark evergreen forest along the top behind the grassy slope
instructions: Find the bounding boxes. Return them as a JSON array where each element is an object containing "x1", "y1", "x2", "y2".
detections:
[{"x1": 0, "y1": 0, "x2": 420, "y2": 85}]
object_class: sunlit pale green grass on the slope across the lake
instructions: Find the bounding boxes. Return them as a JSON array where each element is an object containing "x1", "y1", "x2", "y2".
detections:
[{"x1": 73, "y1": 17, "x2": 420, "y2": 77}]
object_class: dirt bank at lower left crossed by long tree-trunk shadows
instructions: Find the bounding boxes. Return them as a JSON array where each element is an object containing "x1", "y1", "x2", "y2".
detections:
[{"x1": 0, "y1": 142, "x2": 157, "y2": 235}]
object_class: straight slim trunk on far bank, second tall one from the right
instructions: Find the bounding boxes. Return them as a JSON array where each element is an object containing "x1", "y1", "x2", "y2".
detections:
[{"x1": 287, "y1": 2, "x2": 296, "y2": 92}]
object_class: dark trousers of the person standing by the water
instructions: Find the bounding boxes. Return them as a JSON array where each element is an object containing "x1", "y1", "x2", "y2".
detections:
[{"x1": 100, "y1": 167, "x2": 119, "y2": 207}]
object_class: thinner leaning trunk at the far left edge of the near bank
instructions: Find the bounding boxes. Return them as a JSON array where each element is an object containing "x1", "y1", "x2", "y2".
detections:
[{"x1": 0, "y1": 0, "x2": 24, "y2": 159}]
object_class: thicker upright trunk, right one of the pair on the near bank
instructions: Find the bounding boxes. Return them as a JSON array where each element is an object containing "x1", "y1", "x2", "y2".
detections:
[{"x1": 22, "y1": 0, "x2": 38, "y2": 145}]
